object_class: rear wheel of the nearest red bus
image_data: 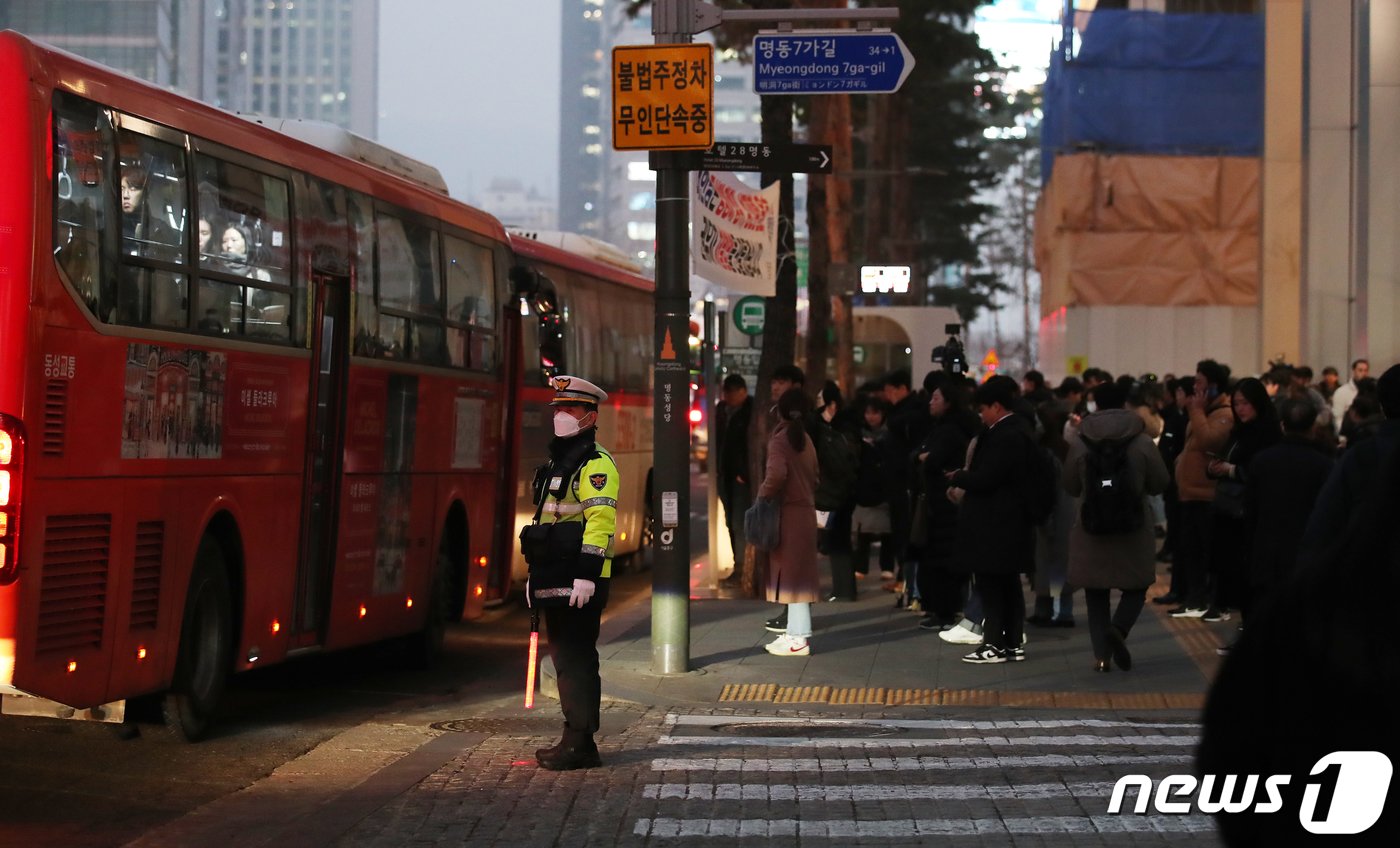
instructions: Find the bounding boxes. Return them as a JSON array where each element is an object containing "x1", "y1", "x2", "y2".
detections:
[{"x1": 162, "y1": 537, "x2": 234, "y2": 742}]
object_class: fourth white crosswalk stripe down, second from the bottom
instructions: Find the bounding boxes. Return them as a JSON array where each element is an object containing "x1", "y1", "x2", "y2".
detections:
[{"x1": 641, "y1": 782, "x2": 1113, "y2": 803}]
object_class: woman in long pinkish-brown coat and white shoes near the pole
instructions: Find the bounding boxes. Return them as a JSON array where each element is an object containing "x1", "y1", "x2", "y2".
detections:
[{"x1": 759, "y1": 389, "x2": 820, "y2": 656}]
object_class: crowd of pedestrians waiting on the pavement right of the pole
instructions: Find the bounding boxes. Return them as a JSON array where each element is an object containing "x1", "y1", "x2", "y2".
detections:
[{"x1": 717, "y1": 360, "x2": 1400, "y2": 672}]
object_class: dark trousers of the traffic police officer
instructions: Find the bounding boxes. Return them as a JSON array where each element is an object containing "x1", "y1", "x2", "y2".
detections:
[{"x1": 545, "y1": 579, "x2": 608, "y2": 744}]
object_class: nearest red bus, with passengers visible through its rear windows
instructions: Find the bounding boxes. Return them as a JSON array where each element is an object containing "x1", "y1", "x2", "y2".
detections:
[{"x1": 0, "y1": 32, "x2": 650, "y2": 739}]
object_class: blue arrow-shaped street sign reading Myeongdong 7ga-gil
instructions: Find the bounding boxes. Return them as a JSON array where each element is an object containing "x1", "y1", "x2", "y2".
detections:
[{"x1": 753, "y1": 29, "x2": 914, "y2": 94}]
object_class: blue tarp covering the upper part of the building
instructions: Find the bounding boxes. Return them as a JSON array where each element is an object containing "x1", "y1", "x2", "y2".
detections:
[{"x1": 1042, "y1": 10, "x2": 1264, "y2": 181}]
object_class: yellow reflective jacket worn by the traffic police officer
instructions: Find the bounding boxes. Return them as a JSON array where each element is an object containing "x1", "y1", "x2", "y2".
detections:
[{"x1": 539, "y1": 445, "x2": 619, "y2": 579}]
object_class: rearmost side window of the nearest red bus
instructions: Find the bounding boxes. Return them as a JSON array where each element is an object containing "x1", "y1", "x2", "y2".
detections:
[{"x1": 53, "y1": 95, "x2": 113, "y2": 320}]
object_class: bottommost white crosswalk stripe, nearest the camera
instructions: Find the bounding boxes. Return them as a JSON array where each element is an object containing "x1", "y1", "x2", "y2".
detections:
[{"x1": 633, "y1": 816, "x2": 1215, "y2": 840}]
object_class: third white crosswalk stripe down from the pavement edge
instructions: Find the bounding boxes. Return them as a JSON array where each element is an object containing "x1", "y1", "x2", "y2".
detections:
[{"x1": 651, "y1": 754, "x2": 1191, "y2": 774}]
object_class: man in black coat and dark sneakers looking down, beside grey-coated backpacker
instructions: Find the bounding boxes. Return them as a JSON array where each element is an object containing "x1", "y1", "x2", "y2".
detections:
[{"x1": 948, "y1": 376, "x2": 1036, "y2": 663}]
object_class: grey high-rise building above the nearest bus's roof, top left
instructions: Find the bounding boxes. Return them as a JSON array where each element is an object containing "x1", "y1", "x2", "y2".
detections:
[{"x1": 0, "y1": 0, "x2": 379, "y2": 137}]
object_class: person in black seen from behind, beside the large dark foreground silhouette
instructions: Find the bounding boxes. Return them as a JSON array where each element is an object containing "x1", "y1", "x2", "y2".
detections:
[{"x1": 1243, "y1": 397, "x2": 1331, "y2": 614}]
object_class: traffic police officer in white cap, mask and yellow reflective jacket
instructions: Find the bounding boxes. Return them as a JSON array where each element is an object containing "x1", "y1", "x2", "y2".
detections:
[{"x1": 531, "y1": 375, "x2": 619, "y2": 771}]
